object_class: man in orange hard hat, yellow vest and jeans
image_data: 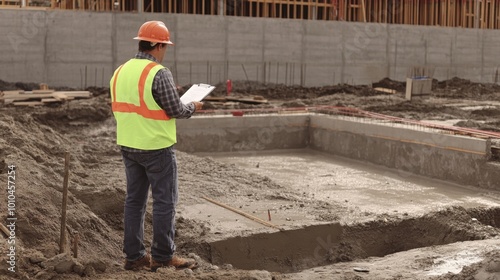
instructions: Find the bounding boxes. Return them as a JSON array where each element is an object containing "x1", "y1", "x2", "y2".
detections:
[{"x1": 110, "y1": 21, "x2": 203, "y2": 271}]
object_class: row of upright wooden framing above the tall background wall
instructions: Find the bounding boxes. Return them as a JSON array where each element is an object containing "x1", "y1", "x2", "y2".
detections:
[{"x1": 0, "y1": 0, "x2": 500, "y2": 29}]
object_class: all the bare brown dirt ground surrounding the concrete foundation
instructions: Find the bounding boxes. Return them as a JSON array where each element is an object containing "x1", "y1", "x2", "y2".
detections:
[{"x1": 0, "y1": 78, "x2": 500, "y2": 280}]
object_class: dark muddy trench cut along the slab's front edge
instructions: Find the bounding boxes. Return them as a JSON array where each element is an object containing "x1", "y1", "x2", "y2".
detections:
[{"x1": 210, "y1": 208, "x2": 500, "y2": 273}]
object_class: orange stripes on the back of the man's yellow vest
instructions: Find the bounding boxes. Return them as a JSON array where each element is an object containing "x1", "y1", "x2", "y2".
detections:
[{"x1": 111, "y1": 62, "x2": 170, "y2": 120}]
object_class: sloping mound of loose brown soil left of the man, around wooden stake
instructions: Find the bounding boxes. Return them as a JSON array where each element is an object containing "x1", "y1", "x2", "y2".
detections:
[{"x1": 0, "y1": 108, "x2": 121, "y2": 276}]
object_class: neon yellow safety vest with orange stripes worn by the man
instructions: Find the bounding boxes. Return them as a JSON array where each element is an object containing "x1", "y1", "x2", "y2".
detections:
[{"x1": 110, "y1": 58, "x2": 177, "y2": 150}]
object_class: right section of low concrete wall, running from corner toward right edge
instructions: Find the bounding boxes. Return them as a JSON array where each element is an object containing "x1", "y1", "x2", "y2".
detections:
[{"x1": 310, "y1": 116, "x2": 497, "y2": 188}]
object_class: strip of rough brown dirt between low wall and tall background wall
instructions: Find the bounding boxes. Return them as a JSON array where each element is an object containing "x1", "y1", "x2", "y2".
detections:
[{"x1": 204, "y1": 78, "x2": 500, "y2": 131}]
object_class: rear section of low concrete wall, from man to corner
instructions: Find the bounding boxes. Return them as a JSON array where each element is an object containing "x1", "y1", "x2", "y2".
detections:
[{"x1": 176, "y1": 115, "x2": 309, "y2": 153}]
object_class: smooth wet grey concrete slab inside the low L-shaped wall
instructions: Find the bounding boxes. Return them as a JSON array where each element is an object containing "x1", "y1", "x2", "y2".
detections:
[{"x1": 202, "y1": 149, "x2": 500, "y2": 219}]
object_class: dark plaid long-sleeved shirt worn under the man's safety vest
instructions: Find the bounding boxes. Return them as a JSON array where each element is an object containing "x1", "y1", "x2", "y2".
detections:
[{"x1": 121, "y1": 52, "x2": 195, "y2": 152}]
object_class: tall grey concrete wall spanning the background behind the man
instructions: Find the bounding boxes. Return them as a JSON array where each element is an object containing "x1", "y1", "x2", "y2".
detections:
[{"x1": 0, "y1": 9, "x2": 500, "y2": 87}]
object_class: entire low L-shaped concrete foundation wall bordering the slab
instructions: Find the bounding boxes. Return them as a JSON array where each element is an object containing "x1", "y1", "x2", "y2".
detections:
[{"x1": 177, "y1": 115, "x2": 500, "y2": 189}]
